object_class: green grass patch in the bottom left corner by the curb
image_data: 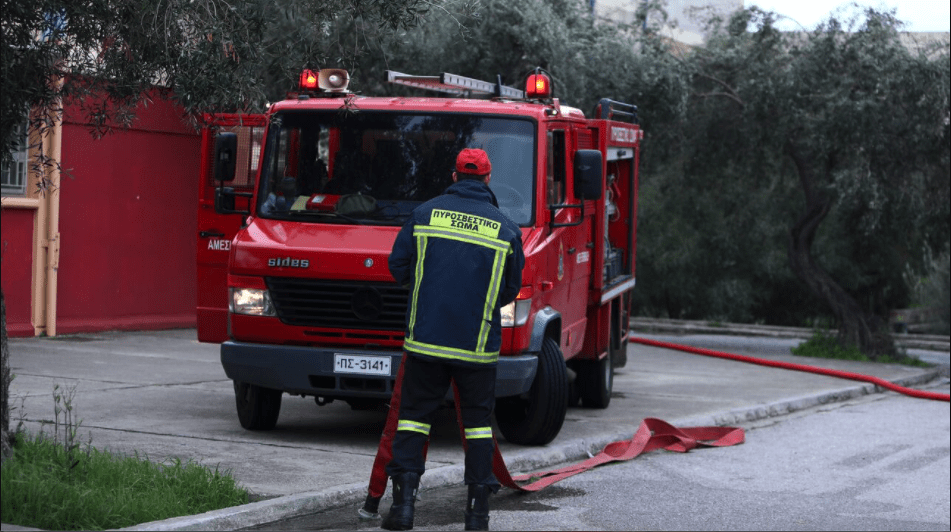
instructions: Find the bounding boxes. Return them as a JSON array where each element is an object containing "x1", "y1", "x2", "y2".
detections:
[{"x1": 0, "y1": 433, "x2": 248, "y2": 530}]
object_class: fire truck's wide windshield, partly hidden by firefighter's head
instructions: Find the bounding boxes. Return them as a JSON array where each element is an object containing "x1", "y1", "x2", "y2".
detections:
[{"x1": 257, "y1": 111, "x2": 535, "y2": 225}]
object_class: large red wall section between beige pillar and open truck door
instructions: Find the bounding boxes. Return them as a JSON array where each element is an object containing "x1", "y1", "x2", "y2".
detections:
[{"x1": 57, "y1": 91, "x2": 200, "y2": 333}]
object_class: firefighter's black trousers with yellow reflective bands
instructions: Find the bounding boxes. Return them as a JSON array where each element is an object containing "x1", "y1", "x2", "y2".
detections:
[{"x1": 386, "y1": 353, "x2": 499, "y2": 489}]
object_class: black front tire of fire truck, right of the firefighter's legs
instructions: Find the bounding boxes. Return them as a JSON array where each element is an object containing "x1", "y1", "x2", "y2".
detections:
[{"x1": 495, "y1": 338, "x2": 568, "y2": 445}]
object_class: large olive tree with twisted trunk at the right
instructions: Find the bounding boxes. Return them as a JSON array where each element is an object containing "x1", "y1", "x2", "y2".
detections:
[{"x1": 667, "y1": 8, "x2": 951, "y2": 356}]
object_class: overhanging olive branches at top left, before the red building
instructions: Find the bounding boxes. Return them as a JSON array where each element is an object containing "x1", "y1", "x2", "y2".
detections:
[{"x1": 0, "y1": 0, "x2": 445, "y2": 455}]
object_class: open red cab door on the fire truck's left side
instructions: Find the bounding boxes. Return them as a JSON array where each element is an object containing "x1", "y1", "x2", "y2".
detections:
[{"x1": 196, "y1": 114, "x2": 266, "y2": 343}]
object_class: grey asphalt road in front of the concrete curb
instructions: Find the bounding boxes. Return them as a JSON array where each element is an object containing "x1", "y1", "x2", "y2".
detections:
[{"x1": 247, "y1": 379, "x2": 951, "y2": 531}]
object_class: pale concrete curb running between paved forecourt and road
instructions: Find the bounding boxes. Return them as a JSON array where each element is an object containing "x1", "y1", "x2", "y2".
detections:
[{"x1": 115, "y1": 369, "x2": 941, "y2": 531}]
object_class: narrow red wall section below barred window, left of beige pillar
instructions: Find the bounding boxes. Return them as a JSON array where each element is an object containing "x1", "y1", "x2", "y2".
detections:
[{"x1": 0, "y1": 208, "x2": 36, "y2": 336}]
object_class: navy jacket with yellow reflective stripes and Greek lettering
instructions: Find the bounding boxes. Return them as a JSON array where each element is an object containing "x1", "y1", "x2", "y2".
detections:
[{"x1": 389, "y1": 179, "x2": 525, "y2": 364}]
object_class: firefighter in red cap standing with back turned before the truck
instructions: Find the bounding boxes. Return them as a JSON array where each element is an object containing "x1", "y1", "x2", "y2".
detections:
[{"x1": 381, "y1": 149, "x2": 525, "y2": 530}]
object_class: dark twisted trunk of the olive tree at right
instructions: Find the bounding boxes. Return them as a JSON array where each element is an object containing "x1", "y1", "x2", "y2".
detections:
[{"x1": 786, "y1": 144, "x2": 897, "y2": 360}]
